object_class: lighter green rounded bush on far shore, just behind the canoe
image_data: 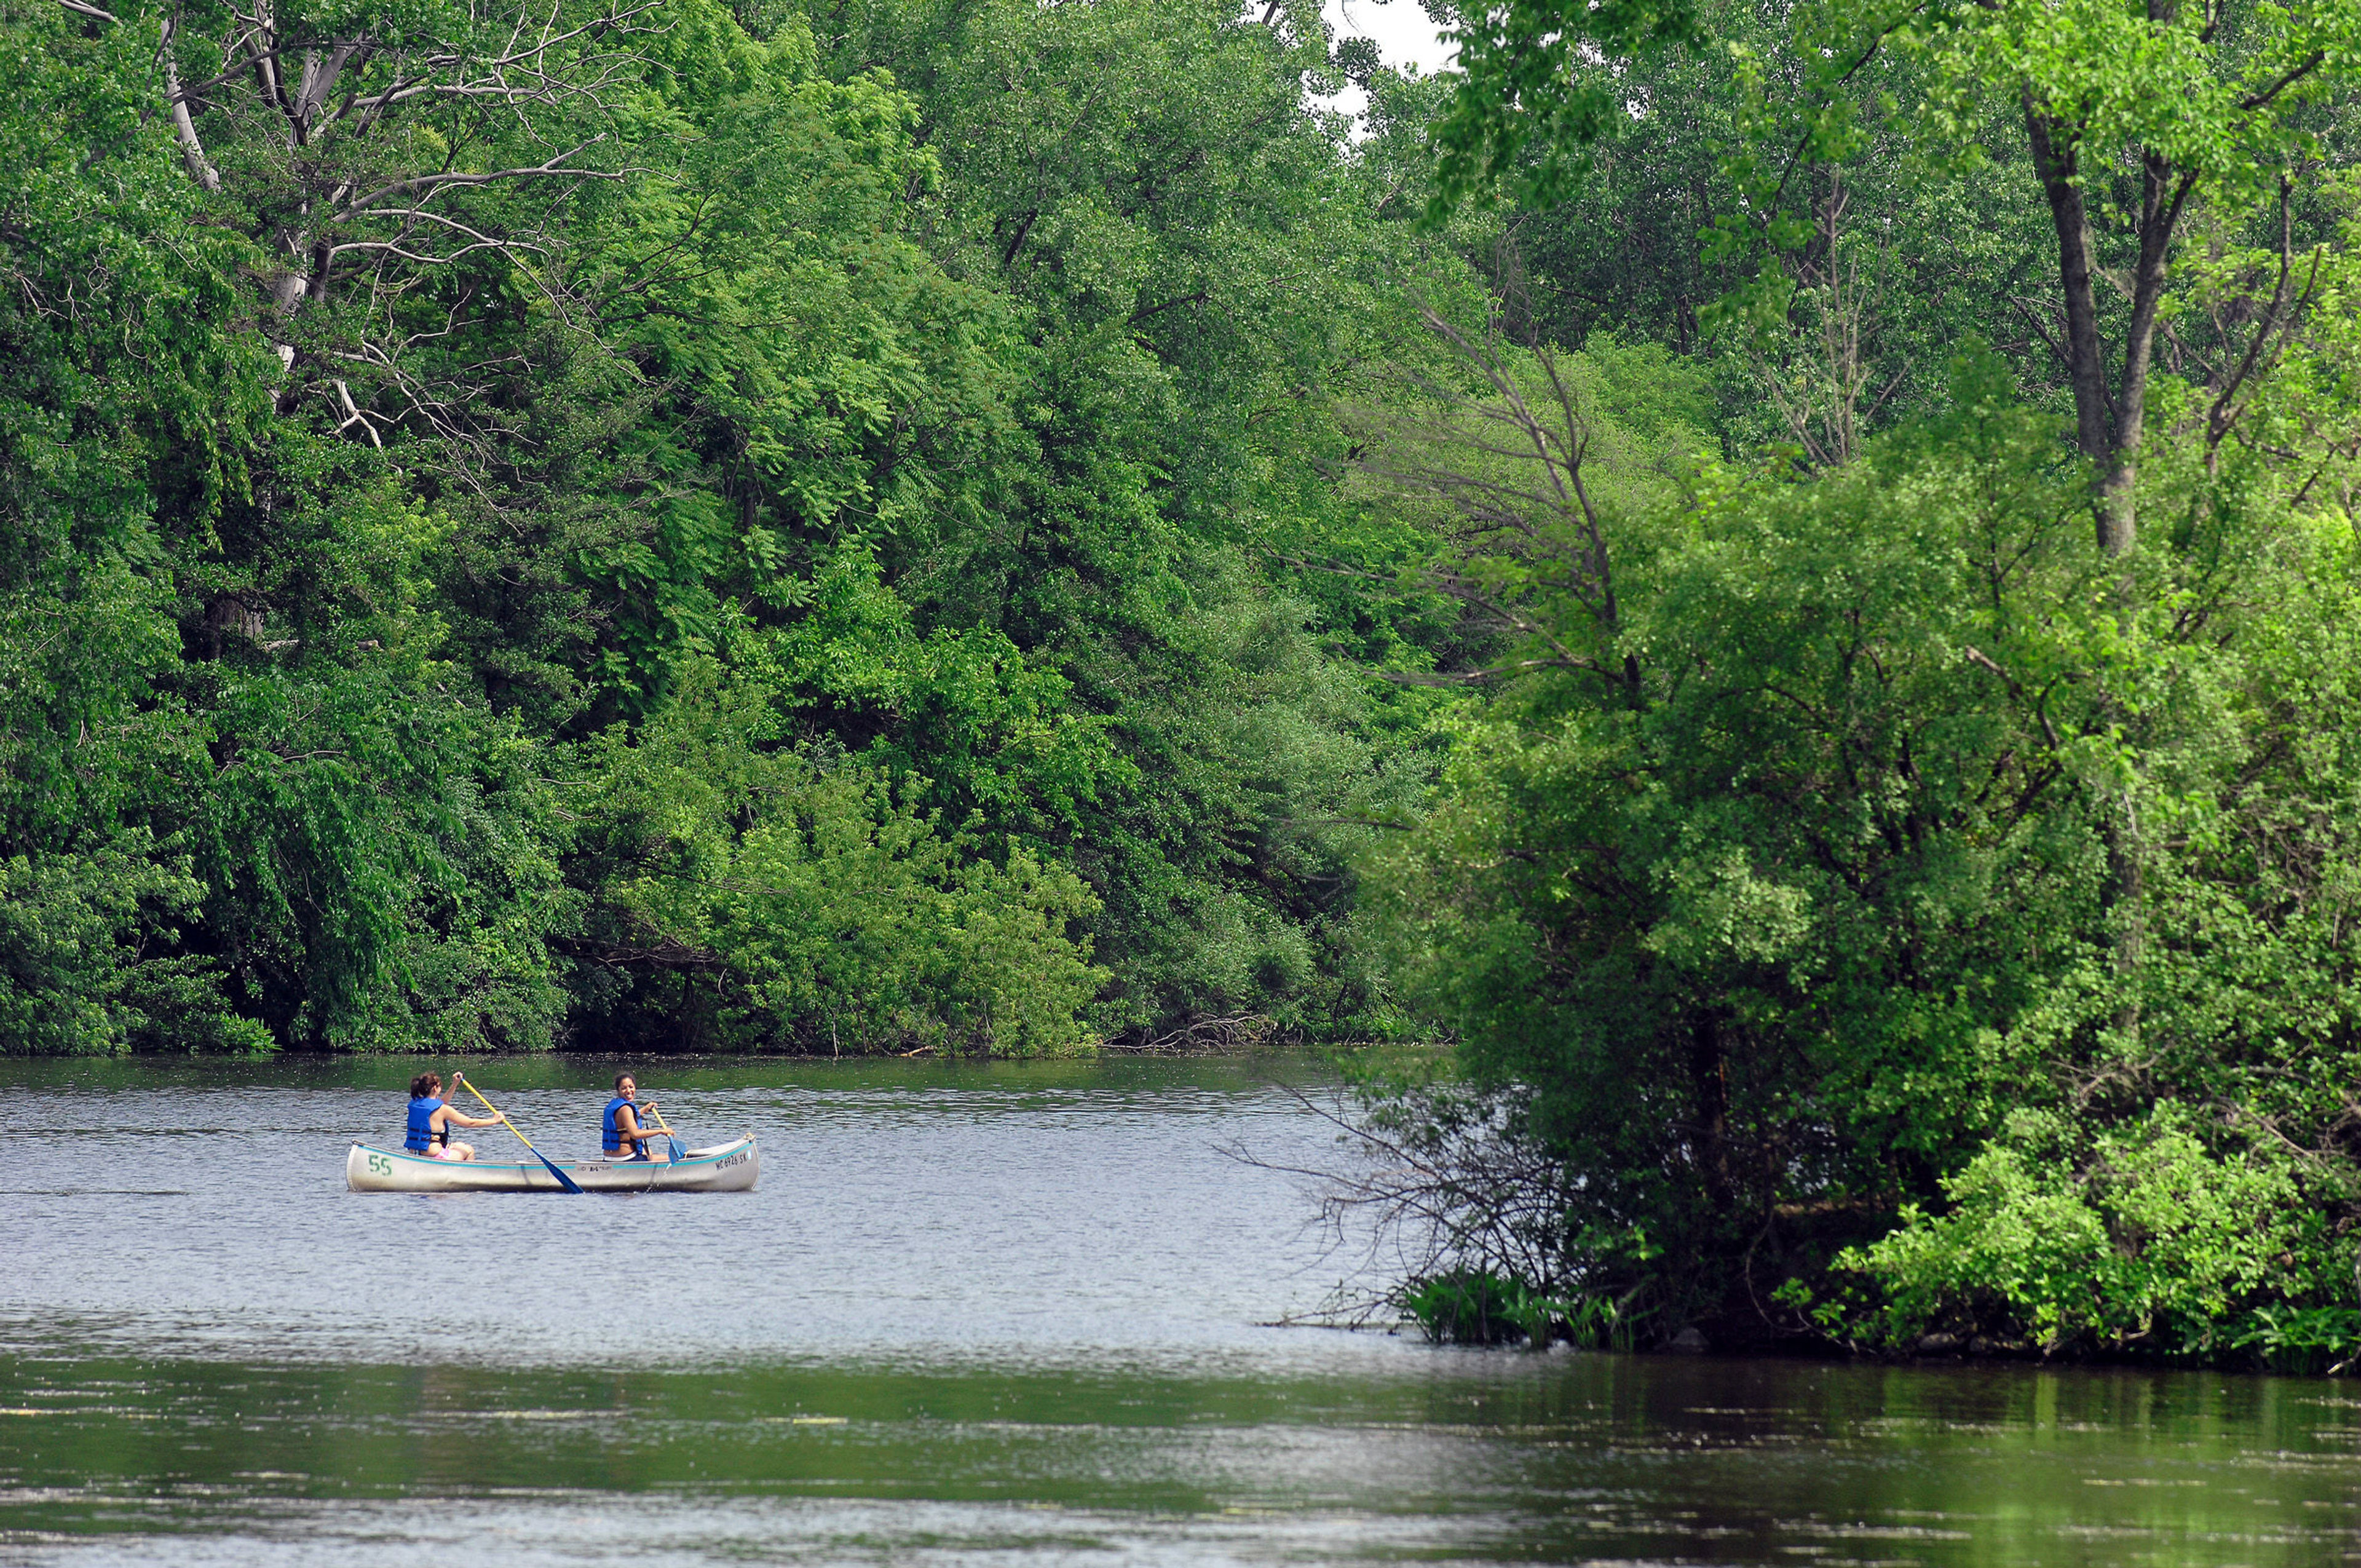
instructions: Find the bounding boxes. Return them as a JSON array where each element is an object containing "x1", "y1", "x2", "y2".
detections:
[{"x1": 585, "y1": 663, "x2": 1105, "y2": 1056}]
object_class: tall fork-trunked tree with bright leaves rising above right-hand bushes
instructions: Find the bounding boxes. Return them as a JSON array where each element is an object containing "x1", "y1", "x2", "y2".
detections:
[{"x1": 1436, "y1": 0, "x2": 2361, "y2": 555}]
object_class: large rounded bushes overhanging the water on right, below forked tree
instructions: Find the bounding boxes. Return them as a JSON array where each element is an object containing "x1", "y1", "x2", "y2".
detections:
[{"x1": 1365, "y1": 340, "x2": 2361, "y2": 1368}]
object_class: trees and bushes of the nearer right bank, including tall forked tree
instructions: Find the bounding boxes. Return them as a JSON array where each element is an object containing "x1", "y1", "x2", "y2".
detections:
[{"x1": 1336, "y1": 0, "x2": 2361, "y2": 1368}]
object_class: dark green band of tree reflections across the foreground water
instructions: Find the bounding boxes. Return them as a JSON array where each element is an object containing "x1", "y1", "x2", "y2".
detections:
[{"x1": 0, "y1": 1353, "x2": 2356, "y2": 1563}]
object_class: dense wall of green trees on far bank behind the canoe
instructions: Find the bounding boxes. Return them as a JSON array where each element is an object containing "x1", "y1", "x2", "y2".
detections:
[{"x1": 0, "y1": 0, "x2": 1473, "y2": 1051}]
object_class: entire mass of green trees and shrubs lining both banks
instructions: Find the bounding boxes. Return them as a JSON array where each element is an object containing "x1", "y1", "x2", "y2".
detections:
[{"x1": 14, "y1": 0, "x2": 2361, "y2": 1369}]
